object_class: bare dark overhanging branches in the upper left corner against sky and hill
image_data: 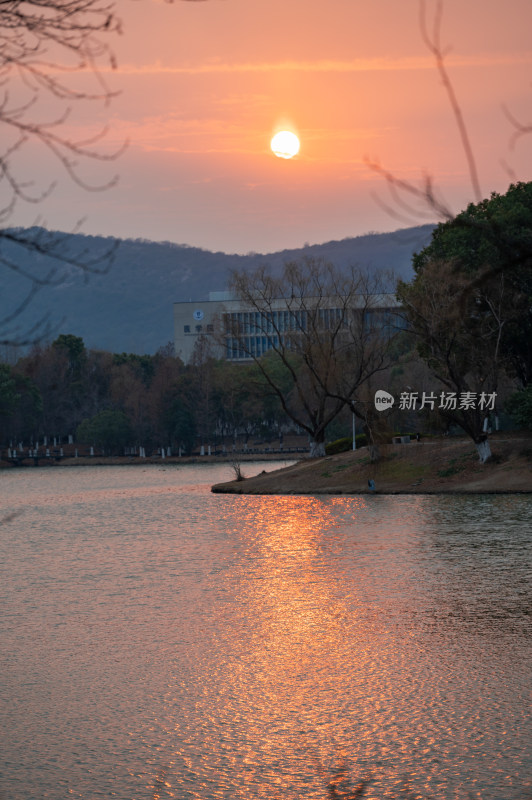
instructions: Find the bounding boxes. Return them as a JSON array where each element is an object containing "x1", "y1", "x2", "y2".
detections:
[{"x1": 0, "y1": 0, "x2": 204, "y2": 344}]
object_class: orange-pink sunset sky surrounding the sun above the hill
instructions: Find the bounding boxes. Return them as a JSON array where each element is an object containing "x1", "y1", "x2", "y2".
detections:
[{"x1": 12, "y1": 0, "x2": 532, "y2": 253}]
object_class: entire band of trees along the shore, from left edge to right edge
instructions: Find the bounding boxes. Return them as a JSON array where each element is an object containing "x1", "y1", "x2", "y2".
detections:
[{"x1": 4, "y1": 182, "x2": 532, "y2": 461}]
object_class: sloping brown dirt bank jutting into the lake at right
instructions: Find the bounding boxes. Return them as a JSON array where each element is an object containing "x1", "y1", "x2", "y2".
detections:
[{"x1": 212, "y1": 433, "x2": 532, "y2": 494}]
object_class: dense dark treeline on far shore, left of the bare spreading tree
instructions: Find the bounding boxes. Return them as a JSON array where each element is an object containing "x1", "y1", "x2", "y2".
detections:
[{"x1": 0, "y1": 334, "x2": 300, "y2": 454}]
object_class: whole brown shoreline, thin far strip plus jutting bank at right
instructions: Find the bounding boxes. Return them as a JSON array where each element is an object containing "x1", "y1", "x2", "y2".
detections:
[{"x1": 5, "y1": 431, "x2": 532, "y2": 495}]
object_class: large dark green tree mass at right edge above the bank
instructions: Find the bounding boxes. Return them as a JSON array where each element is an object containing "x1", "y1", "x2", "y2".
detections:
[{"x1": 398, "y1": 183, "x2": 532, "y2": 460}]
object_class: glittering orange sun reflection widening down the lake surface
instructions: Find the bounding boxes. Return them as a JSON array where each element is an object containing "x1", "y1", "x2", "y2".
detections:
[{"x1": 140, "y1": 497, "x2": 528, "y2": 800}]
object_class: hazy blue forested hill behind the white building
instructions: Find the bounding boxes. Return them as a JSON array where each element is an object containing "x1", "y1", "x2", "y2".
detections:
[{"x1": 0, "y1": 225, "x2": 433, "y2": 354}]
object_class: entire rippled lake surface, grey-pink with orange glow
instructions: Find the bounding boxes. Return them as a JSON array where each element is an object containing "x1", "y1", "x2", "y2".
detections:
[{"x1": 0, "y1": 465, "x2": 532, "y2": 800}]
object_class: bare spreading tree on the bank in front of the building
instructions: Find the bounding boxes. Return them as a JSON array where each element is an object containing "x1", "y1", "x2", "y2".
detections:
[{"x1": 227, "y1": 258, "x2": 393, "y2": 456}]
